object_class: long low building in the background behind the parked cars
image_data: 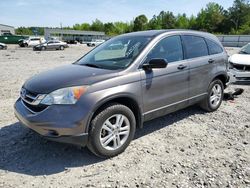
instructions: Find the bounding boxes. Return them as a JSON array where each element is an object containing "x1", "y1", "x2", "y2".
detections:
[{"x1": 44, "y1": 28, "x2": 107, "y2": 43}]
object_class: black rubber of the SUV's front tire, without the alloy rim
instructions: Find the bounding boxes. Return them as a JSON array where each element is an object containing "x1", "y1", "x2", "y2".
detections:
[{"x1": 90, "y1": 105, "x2": 136, "y2": 157}]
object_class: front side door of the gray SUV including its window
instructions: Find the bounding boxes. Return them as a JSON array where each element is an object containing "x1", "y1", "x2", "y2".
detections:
[{"x1": 141, "y1": 35, "x2": 189, "y2": 121}]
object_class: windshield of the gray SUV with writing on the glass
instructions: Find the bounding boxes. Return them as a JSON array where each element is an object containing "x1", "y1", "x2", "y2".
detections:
[{"x1": 76, "y1": 36, "x2": 151, "y2": 70}]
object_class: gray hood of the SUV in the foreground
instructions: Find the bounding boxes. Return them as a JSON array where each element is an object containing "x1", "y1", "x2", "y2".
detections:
[{"x1": 23, "y1": 64, "x2": 118, "y2": 94}]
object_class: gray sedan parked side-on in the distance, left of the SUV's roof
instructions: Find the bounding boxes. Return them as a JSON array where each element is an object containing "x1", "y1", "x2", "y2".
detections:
[{"x1": 33, "y1": 40, "x2": 69, "y2": 50}]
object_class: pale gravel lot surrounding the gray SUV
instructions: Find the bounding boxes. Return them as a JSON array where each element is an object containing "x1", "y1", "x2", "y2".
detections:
[{"x1": 0, "y1": 46, "x2": 250, "y2": 188}]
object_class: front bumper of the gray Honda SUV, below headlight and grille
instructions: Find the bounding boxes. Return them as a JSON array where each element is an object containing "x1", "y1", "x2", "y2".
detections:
[{"x1": 14, "y1": 98, "x2": 88, "y2": 146}]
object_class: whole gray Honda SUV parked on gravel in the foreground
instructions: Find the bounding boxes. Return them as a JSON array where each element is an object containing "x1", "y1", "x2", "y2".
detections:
[{"x1": 15, "y1": 30, "x2": 228, "y2": 157}]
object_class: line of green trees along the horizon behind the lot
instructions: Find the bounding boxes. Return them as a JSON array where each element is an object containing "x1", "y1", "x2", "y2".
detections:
[{"x1": 16, "y1": 0, "x2": 250, "y2": 36}]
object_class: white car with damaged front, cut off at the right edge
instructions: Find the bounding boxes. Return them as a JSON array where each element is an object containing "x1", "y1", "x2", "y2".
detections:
[{"x1": 228, "y1": 43, "x2": 250, "y2": 81}]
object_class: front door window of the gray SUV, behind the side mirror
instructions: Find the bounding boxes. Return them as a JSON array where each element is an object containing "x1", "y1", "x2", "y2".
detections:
[{"x1": 147, "y1": 36, "x2": 183, "y2": 63}]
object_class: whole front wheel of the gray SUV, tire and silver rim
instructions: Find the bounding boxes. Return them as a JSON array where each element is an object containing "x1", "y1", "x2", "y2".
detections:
[{"x1": 87, "y1": 103, "x2": 136, "y2": 158}]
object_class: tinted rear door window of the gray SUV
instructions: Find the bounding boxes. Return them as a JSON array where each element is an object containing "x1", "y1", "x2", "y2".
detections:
[{"x1": 183, "y1": 35, "x2": 208, "y2": 59}]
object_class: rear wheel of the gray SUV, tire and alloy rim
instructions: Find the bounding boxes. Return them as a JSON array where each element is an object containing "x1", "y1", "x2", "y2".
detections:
[{"x1": 200, "y1": 79, "x2": 224, "y2": 112}]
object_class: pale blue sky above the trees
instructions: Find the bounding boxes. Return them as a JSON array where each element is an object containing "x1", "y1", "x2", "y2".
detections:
[{"x1": 0, "y1": 0, "x2": 233, "y2": 27}]
